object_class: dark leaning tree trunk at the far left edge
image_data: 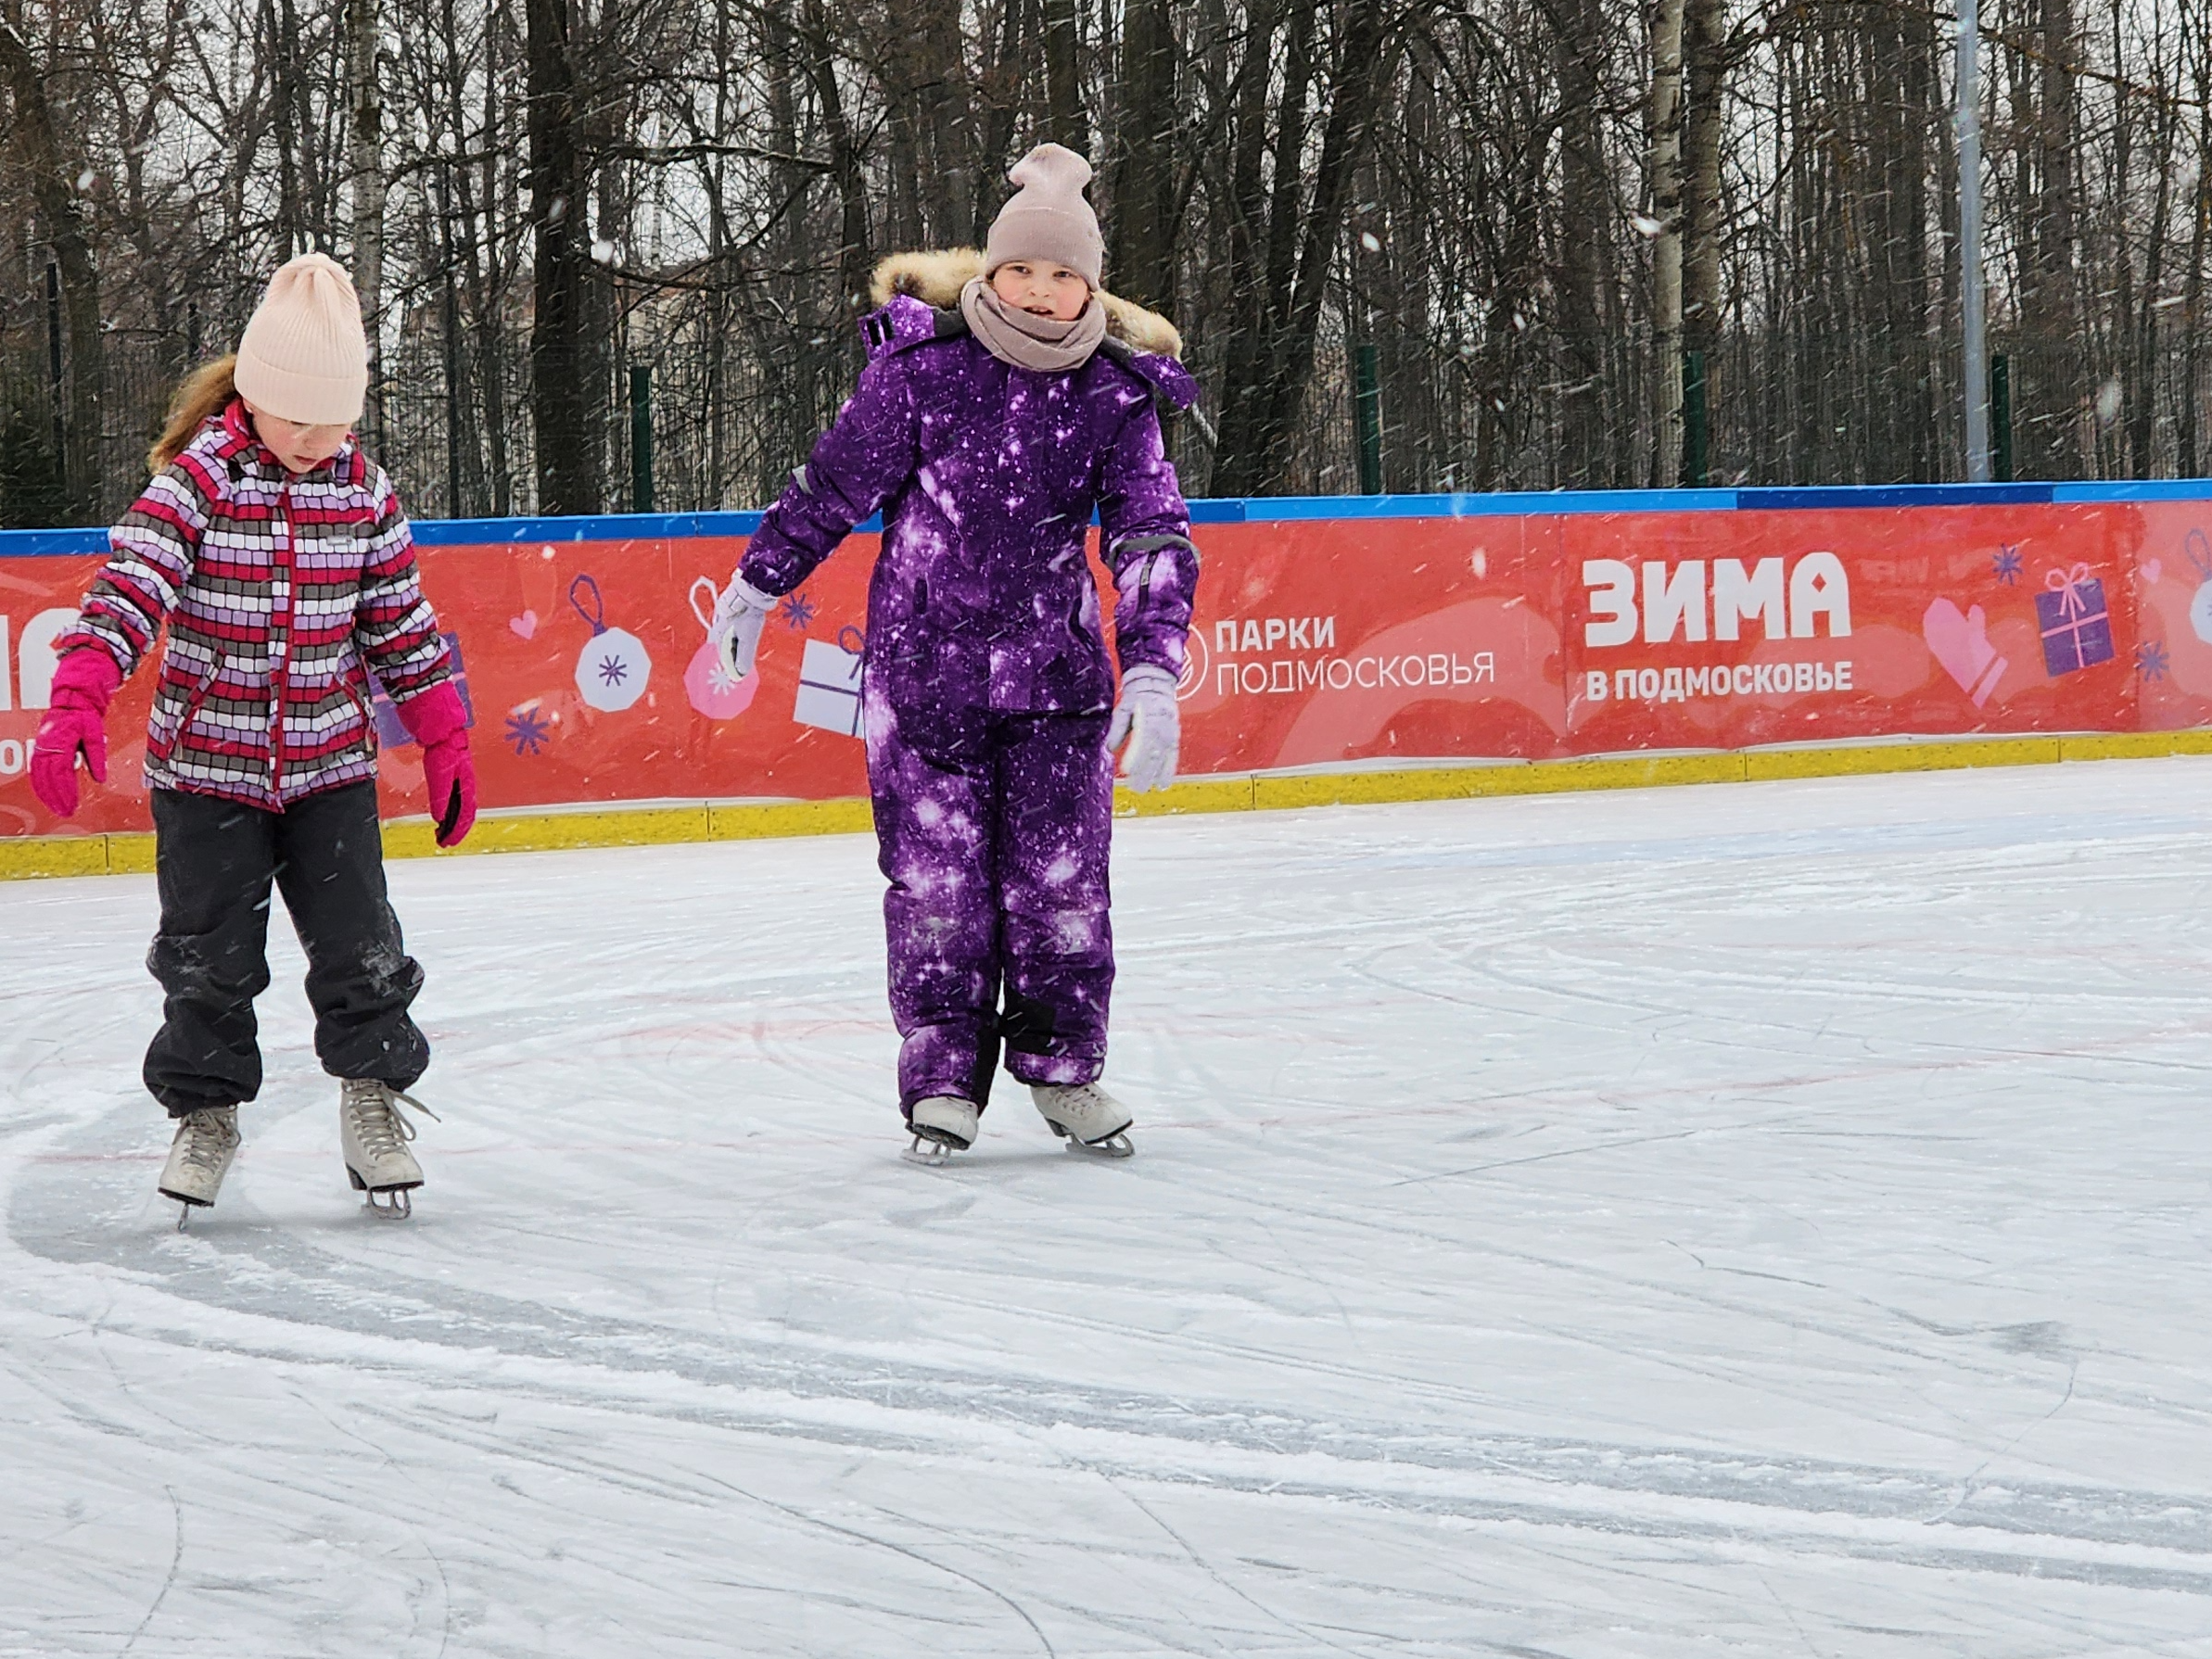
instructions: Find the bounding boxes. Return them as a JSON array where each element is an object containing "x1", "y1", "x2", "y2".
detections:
[{"x1": 0, "y1": 19, "x2": 107, "y2": 525}]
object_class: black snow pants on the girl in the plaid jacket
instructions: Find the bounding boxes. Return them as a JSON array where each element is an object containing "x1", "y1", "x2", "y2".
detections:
[{"x1": 146, "y1": 780, "x2": 429, "y2": 1117}]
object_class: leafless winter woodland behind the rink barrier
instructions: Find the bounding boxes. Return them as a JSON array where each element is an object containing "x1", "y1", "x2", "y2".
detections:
[{"x1": 0, "y1": 0, "x2": 2212, "y2": 522}]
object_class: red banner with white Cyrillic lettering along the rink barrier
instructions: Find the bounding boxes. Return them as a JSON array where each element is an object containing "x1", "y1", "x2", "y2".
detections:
[{"x1": 0, "y1": 487, "x2": 2212, "y2": 836}]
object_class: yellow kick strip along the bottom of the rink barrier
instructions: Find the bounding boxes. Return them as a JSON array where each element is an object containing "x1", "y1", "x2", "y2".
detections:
[{"x1": 13, "y1": 730, "x2": 2212, "y2": 880}]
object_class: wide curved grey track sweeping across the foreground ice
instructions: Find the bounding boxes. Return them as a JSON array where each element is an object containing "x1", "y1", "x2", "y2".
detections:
[{"x1": 9, "y1": 1096, "x2": 2212, "y2": 1595}]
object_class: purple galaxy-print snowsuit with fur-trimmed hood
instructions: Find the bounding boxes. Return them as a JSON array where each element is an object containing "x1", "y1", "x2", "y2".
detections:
[{"x1": 739, "y1": 294, "x2": 1199, "y2": 1110}]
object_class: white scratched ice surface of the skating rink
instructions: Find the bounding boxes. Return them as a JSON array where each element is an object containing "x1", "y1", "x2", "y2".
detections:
[{"x1": 0, "y1": 761, "x2": 2212, "y2": 1659}]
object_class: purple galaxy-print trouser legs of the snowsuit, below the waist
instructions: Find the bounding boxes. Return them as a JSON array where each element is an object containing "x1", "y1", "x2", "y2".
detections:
[{"x1": 867, "y1": 688, "x2": 1112, "y2": 1110}]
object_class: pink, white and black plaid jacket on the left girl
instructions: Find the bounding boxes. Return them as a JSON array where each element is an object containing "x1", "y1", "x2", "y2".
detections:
[{"x1": 56, "y1": 400, "x2": 449, "y2": 810}]
